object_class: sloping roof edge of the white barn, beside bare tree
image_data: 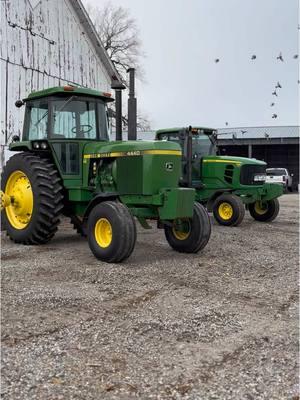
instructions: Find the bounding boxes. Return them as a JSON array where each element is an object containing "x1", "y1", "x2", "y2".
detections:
[{"x1": 69, "y1": 0, "x2": 123, "y2": 88}]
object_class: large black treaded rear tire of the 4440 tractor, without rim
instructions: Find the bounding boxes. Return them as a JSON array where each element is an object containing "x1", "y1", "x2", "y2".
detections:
[{"x1": 1, "y1": 153, "x2": 63, "y2": 245}]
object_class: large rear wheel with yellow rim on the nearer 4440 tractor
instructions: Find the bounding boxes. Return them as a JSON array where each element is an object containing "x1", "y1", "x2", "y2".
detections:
[{"x1": 1, "y1": 153, "x2": 63, "y2": 244}]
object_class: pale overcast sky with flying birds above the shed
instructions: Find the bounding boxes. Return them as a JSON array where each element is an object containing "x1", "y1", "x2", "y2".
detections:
[{"x1": 84, "y1": 0, "x2": 300, "y2": 129}]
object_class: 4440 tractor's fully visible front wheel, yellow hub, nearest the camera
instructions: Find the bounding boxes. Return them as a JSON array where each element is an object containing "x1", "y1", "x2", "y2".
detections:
[{"x1": 87, "y1": 201, "x2": 136, "y2": 263}]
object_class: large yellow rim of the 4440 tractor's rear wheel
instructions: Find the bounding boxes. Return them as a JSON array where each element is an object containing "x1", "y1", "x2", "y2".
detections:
[{"x1": 5, "y1": 171, "x2": 33, "y2": 229}]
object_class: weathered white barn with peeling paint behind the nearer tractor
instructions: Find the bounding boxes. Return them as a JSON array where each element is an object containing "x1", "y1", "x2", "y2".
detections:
[{"x1": 0, "y1": 0, "x2": 119, "y2": 165}]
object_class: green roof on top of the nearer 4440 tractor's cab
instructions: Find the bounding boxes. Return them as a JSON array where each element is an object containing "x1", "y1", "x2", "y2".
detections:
[{"x1": 24, "y1": 85, "x2": 114, "y2": 101}]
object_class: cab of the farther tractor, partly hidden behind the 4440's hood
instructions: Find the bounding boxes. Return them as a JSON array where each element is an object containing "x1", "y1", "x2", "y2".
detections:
[{"x1": 156, "y1": 127, "x2": 217, "y2": 187}]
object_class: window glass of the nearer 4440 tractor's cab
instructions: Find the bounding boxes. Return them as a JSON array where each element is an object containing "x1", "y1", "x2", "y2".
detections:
[{"x1": 24, "y1": 96, "x2": 108, "y2": 140}]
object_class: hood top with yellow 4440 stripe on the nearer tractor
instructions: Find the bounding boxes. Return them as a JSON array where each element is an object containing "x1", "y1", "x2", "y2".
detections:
[{"x1": 84, "y1": 141, "x2": 181, "y2": 158}]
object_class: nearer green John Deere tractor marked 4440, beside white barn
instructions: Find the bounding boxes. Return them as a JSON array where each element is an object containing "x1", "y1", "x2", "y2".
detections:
[{"x1": 1, "y1": 86, "x2": 211, "y2": 262}]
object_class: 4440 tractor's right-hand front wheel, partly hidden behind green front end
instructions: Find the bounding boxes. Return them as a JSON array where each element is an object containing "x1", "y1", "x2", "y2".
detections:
[{"x1": 164, "y1": 203, "x2": 211, "y2": 253}]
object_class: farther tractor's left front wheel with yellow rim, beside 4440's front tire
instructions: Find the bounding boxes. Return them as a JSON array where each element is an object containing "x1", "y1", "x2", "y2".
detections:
[{"x1": 213, "y1": 193, "x2": 245, "y2": 226}]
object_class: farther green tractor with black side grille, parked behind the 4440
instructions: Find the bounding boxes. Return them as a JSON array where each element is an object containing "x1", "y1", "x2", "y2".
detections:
[{"x1": 156, "y1": 127, "x2": 283, "y2": 226}]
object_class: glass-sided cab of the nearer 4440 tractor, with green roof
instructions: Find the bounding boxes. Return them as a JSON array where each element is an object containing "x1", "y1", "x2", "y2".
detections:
[{"x1": 10, "y1": 86, "x2": 113, "y2": 179}]
